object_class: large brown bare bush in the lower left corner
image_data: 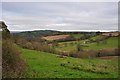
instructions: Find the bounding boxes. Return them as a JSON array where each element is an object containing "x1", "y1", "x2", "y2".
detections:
[{"x1": 2, "y1": 40, "x2": 25, "y2": 78}]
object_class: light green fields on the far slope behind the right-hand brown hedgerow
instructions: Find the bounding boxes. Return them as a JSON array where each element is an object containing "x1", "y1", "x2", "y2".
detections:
[{"x1": 56, "y1": 35, "x2": 118, "y2": 52}]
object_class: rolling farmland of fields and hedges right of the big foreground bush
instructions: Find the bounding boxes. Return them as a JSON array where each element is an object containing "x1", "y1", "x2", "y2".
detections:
[{"x1": 4, "y1": 24, "x2": 119, "y2": 78}]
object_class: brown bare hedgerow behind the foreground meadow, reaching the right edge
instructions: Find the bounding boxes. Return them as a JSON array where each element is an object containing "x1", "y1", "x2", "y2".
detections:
[{"x1": 60, "y1": 48, "x2": 120, "y2": 58}]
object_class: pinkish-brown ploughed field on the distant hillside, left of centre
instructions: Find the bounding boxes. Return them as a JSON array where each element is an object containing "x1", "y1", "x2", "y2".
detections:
[{"x1": 42, "y1": 35, "x2": 70, "y2": 41}]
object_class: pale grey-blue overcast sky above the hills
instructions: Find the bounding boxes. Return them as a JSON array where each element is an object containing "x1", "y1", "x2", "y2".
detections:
[{"x1": 0, "y1": 2, "x2": 118, "y2": 31}]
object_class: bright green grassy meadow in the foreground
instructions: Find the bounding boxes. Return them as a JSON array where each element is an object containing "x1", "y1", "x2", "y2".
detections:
[{"x1": 21, "y1": 49, "x2": 118, "y2": 78}]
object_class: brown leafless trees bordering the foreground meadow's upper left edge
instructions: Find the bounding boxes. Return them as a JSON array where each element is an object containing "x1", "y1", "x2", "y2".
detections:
[{"x1": 15, "y1": 38, "x2": 56, "y2": 53}]
